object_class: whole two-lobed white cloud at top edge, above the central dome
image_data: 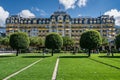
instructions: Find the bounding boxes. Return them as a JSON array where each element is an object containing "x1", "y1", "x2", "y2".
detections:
[{"x1": 59, "y1": 0, "x2": 87, "y2": 10}]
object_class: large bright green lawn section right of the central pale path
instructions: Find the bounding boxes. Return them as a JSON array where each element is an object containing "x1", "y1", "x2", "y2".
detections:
[{"x1": 57, "y1": 54, "x2": 120, "y2": 80}]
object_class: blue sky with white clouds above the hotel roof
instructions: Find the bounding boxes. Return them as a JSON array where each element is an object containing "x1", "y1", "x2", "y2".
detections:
[{"x1": 0, "y1": 0, "x2": 120, "y2": 26}]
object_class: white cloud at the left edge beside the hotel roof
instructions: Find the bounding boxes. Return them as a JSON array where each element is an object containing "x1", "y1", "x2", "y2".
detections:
[{"x1": 0, "y1": 6, "x2": 9, "y2": 26}]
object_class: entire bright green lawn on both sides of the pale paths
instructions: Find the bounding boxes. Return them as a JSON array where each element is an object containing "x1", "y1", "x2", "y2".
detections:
[{"x1": 0, "y1": 54, "x2": 120, "y2": 80}]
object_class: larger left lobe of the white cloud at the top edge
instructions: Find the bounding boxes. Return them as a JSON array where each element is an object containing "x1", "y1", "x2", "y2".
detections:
[{"x1": 59, "y1": 0, "x2": 77, "y2": 10}]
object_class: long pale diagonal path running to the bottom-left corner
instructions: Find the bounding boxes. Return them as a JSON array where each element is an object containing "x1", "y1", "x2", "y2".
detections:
[{"x1": 3, "y1": 59, "x2": 42, "y2": 80}]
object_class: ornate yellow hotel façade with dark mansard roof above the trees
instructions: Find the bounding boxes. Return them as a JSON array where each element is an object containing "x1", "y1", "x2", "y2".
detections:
[{"x1": 6, "y1": 11, "x2": 116, "y2": 44}]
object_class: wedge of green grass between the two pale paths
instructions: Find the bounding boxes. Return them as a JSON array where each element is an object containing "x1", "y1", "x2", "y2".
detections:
[{"x1": 10, "y1": 55, "x2": 57, "y2": 80}]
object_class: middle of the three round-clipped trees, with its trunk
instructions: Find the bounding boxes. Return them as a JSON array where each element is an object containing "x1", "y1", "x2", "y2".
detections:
[{"x1": 45, "y1": 33, "x2": 63, "y2": 56}]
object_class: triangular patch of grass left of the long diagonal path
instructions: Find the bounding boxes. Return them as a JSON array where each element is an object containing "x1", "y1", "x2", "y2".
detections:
[{"x1": 0, "y1": 54, "x2": 50, "y2": 80}]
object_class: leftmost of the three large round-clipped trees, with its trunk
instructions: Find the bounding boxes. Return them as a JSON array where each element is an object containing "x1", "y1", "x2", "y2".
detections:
[{"x1": 9, "y1": 32, "x2": 30, "y2": 56}]
